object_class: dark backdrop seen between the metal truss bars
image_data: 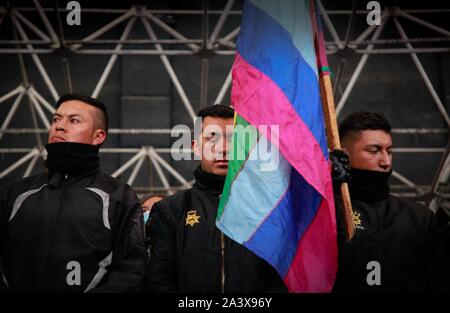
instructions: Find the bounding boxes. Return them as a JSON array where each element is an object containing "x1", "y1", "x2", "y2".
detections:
[{"x1": 0, "y1": 0, "x2": 450, "y2": 204}]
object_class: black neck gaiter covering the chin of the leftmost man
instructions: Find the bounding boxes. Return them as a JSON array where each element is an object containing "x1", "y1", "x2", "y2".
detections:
[{"x1": 45, "y1": 142, "x2": 100, "y2": 177}]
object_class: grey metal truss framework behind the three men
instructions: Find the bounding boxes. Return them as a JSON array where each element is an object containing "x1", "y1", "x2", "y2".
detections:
[{"x1": 0, "y1": 0, "x2": 450, "y2": 211}]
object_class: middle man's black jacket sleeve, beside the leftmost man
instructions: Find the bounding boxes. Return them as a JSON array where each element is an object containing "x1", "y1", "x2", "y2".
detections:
[{"x1": 147, "y1": 200, "x2": 179, "y2": 292}]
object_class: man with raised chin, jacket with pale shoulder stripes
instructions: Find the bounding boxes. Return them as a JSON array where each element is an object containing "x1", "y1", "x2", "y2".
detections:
[{"x1": 0, "y1": 94, "x2": 145, "y2": 292}]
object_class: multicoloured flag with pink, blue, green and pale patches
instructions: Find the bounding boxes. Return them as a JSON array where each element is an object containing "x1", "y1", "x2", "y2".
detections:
[{"x1": 216, "y1": 0, "x2": 337, "y2": 292}]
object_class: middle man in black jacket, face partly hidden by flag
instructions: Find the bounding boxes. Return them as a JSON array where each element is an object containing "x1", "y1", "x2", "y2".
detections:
[{"x1": 147, "y1": 105, "x2": 286, "y2": 293}]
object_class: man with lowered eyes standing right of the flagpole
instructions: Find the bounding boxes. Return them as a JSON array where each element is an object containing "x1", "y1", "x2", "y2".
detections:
[{"x1": 333, "y1": 112, "x2": 442, "y2": 293}]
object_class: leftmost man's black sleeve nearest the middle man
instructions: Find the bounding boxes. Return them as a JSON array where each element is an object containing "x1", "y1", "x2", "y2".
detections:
[{"x1": 92, "y1": 188, "x2": 146, "y2": 292}]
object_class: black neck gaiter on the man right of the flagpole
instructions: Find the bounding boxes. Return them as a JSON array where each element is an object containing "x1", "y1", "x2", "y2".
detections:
[{"x1": 348, "y1": 168, "x2": 392, "y2": 202}]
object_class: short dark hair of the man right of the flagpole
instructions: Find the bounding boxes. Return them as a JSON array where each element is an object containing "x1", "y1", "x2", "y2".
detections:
[{"x1": 339, "y1": 111, "x2": 391, "y2": 140}]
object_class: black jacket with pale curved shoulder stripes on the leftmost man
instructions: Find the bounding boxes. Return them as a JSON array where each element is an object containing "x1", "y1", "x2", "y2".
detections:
[{"x1": 0, "y1": 170, "x2": 146, "y2": 292}]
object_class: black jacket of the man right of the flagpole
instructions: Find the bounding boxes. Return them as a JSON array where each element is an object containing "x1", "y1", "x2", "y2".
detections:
[{"x1": 333, "y1": 196, "x2": 434, "y2": 293}]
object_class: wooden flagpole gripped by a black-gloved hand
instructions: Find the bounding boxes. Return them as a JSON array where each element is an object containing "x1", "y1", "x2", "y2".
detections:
[{"x1": 319, "y1": 73, "x2": 355, "y2": 241}]
